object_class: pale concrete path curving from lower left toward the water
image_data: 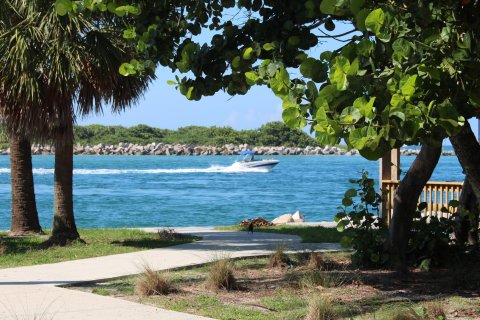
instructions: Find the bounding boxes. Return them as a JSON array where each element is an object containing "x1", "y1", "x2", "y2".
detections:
[{"x1": 0, "y1": 228, "x2": 339, "y2": 320}]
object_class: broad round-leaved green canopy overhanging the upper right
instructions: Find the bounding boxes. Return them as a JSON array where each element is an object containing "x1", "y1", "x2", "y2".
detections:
[{"x1": 64, "y1": 0, "x2": 480, "y2": 159}]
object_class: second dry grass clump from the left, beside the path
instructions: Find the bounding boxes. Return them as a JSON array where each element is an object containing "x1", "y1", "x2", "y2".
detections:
[{"x1": 205, "y1": 258, "x2": 237, "y2": 290}]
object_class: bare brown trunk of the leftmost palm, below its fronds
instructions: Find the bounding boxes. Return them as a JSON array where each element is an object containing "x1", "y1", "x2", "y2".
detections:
[{"x1": 9, "y1": 137, "x2": 42, "y2": 236}]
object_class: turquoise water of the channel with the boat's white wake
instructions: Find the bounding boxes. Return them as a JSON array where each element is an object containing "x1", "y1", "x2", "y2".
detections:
[{"x1": 0, "y1": 156, "x2": 463, "y2": 230}]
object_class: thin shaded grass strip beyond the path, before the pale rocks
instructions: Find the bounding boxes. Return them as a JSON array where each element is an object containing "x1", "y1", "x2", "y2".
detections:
[{"x1": 216, "y1": 225, "x2": 346, "y2": 243}]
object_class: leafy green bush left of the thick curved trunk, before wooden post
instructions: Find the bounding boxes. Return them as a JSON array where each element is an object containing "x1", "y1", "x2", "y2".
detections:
[{"x1": 335, "y1": 171, "x2": 389, "y2": 266}]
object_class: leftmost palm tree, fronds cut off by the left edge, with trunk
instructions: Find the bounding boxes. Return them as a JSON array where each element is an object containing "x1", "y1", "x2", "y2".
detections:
[{"x1": 0, "y1": 1, "x2": 46, "y2": 235}]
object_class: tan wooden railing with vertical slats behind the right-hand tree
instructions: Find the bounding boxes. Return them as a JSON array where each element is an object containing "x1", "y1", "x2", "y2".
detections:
[{"x1": 381, "y1": 180, "x2": 463, "y2": 224}]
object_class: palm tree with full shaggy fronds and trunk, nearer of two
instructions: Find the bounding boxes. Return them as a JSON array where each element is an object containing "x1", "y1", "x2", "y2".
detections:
[{"x1": 0, "y1": 0, "x2": 153, "y2": 245}]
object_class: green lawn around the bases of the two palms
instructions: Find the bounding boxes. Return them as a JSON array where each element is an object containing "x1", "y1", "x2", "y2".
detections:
[{"x1": 0, "y1": 229, "x2": 196, "y2": 268}]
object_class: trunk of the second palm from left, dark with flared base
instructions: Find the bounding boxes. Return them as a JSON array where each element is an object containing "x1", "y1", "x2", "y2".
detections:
[{"x1": 47, "y1": 124, "x2": 80, "y2": 246}]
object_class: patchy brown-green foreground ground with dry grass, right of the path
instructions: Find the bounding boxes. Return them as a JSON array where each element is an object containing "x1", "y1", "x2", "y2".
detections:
[{"x1": 75, "y1": 252, "x2": 480, "y2": 320}]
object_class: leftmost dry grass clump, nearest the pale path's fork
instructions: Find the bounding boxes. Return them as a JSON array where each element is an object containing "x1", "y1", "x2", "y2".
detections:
[{"x1": 135, "y1": 266, "x2": 177, "y2": 297}]
